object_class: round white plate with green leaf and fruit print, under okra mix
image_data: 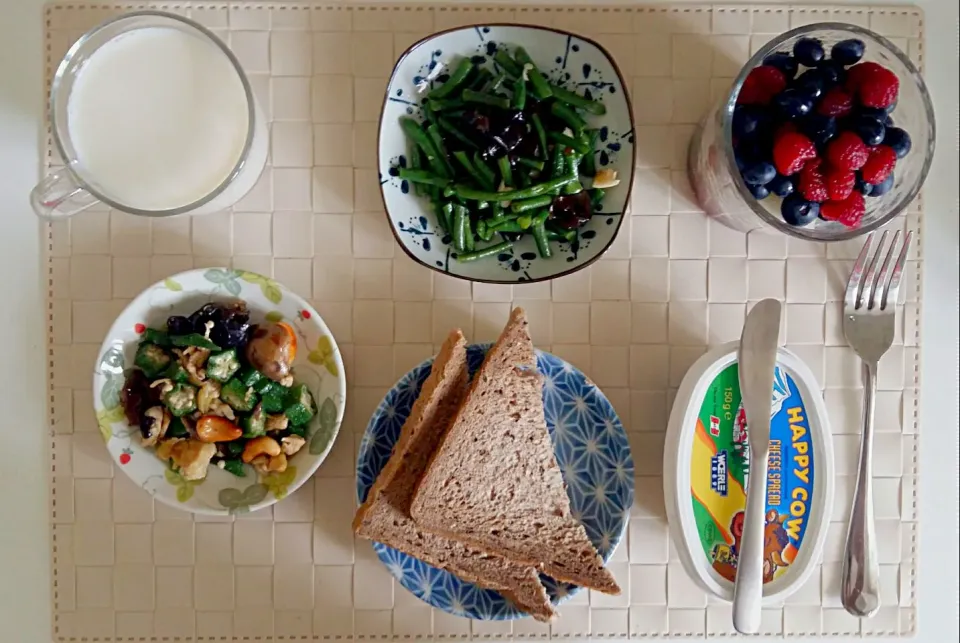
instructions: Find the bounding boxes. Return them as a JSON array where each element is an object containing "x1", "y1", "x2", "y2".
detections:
[{"x1": 93, "y1": 268, "x2": 346, "y2": 514}]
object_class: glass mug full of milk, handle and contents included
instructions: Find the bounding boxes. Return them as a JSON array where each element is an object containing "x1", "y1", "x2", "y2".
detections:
[{"x1": 30, "y1": 11, "x2": 269, "y2": 219}]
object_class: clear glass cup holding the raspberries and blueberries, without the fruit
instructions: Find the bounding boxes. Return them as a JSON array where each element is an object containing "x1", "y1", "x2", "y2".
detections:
[{"x1": 687, "y1": 23, "x2": 936, "y2": 241}]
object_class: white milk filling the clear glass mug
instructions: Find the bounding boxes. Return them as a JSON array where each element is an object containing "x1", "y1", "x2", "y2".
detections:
[{"x1": 67, "y1": 27, "x2": 266, "y2": 211}]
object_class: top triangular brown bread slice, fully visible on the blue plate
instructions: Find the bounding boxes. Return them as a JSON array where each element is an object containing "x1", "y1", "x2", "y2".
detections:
[{"x1": 410, "y1": 308, "x2": 620, "y2": 594}]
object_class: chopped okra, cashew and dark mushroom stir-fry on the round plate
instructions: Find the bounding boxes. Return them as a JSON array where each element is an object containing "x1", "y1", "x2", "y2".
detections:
[{"x1": 121, "y1": 301, "x2": 316, "y2": 480}]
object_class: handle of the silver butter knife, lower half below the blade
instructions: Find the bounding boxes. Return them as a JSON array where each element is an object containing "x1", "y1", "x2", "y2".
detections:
[{"x1": 733, "y1": 452, "x2": 768, "y2": 634}]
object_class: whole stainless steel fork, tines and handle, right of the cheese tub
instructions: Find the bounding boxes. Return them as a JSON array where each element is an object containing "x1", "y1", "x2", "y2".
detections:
[{"x1": 840, "y1": 230, "x2": 913, "y2": 616}]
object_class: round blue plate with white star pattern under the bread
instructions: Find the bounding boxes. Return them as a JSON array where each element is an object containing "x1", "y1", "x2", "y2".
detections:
[{"x1": 357, "y1": 344, "x2": 633, "y2": 621}]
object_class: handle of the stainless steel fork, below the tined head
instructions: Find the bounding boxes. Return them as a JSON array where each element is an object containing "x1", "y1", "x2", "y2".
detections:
[{"x1": 840, "y1": 362, "x2": 880, "y2": 616}]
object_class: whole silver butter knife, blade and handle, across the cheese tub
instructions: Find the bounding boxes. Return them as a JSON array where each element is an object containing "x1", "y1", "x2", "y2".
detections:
[{"x1": 733, "y1": 299, "x2": 780, "y2": 634}]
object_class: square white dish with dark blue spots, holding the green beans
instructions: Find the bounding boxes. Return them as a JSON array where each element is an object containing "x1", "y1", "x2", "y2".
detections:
[{"x1": 378, "y1": 25, "x2": 634, "y2": 283}]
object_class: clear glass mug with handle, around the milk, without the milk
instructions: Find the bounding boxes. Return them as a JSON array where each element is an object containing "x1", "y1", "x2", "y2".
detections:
[{"x1": 30, "y1": 10, "x2": 269, "y2": 219}]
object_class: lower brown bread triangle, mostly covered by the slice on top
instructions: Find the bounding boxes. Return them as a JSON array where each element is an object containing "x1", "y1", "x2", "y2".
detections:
[{"x1": 353, "y1": 330, "x2": 555, "y2": 621}]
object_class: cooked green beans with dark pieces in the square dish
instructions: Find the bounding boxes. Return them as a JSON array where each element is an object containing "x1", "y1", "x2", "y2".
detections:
[{"x1": 396, "y1": 45, "x2": 619, "y2": 261}]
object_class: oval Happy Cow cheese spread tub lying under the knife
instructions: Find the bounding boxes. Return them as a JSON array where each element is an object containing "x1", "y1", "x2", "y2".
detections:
[{"x1": 663, "y1": 342, "x2": 834, "y2": 603}]
